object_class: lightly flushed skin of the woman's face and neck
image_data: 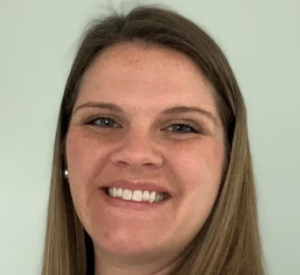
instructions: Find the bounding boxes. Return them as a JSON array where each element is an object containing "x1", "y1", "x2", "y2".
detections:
[{"x1": 66, "y1": 43, "x2": 225, "y2": 275}]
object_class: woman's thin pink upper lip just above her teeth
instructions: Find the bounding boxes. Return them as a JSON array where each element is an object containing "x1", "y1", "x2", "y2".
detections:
[{"x1": 102, "y1": 179, "x2": 171, "y2": 196}]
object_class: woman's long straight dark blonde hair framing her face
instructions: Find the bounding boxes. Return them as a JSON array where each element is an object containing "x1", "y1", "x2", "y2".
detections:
[{"x1": 42, "y1": 6, "x2": 264, "y2": 275}]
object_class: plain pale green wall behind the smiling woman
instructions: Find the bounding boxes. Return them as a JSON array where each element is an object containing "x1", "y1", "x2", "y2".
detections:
[{"x1": 0, "y1": 0, "x2": 300, "y2": 275}]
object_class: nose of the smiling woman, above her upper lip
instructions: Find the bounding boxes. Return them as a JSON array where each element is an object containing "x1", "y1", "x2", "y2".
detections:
[{"x1": 111, "y1": 131, "x2": 163, "y2": 169}]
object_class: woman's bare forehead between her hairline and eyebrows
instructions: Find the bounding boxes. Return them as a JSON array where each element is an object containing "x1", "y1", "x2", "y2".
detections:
[{"x1": 76, "y1": 43, "x2": 216, "y2": 112}]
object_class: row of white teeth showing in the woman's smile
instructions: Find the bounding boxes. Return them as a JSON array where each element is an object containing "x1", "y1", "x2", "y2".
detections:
[{"x1": 108, "y1": 187, "x2": 164, "y2": 203}]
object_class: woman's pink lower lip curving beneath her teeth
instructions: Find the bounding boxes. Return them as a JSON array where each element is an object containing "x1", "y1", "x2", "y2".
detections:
[{"x1": 100, "y1": 189, "x2": 170, "y2": 211}]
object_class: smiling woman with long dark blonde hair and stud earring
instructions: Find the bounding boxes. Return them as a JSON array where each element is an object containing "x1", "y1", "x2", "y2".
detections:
[{"x1": 43, "y1": 4, "x2": 263, "y2": 275}]
